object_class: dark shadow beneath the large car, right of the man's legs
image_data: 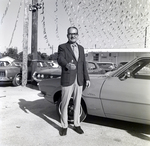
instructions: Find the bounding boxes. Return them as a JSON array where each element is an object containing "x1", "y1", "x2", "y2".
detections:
[{"x1": 84, "y1": 116, "x2": 150, "y2": 141}]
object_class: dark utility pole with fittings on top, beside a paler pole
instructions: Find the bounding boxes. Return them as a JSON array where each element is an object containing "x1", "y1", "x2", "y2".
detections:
[{"x1": 29, "y1": 0, "x2": 42, "y2": 81}]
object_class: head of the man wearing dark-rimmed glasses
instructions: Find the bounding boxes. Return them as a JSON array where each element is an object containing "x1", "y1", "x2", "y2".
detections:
[{"x1": 67, "y1": 28, "x2": 78, "y2": 43}]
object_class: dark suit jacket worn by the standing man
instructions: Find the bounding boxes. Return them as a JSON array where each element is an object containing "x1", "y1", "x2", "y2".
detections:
[{"x1": 57, "y1": 42, "x2": 89, "y2": 86}]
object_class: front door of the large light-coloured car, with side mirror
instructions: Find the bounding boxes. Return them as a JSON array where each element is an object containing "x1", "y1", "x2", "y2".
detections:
[{"x1": 101, "y1": 60, "x2": 150, "y2": 124}]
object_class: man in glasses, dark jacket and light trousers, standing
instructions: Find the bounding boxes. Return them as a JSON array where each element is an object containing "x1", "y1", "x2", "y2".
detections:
[{"x1": 57, "y1": 27, "x2": 90, "y2": 136}]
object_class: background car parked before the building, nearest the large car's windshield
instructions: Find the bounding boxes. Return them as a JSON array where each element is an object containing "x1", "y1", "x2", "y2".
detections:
[{"x1": 97, "y1": 62, "x2": 116, "y2": 72}]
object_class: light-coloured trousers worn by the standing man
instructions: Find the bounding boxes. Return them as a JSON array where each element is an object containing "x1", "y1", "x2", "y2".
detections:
[{"x1": 60, "y1": 77, "x2": 83, "y2": 128}]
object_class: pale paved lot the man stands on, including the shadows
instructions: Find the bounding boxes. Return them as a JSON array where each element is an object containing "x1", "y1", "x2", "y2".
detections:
[{"x1": 0, "y1": 85, "x2": 150, "y2": 146}]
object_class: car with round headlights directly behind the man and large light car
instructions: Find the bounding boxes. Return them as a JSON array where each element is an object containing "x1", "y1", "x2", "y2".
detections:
[{"x1": 33, "y1": 61, "x2": 105, "y2": 82}]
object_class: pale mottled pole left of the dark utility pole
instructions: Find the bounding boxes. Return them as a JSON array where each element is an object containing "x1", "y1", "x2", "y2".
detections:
[{"x1": 22, "y1": 0, "x2": 29, "y2": 86}]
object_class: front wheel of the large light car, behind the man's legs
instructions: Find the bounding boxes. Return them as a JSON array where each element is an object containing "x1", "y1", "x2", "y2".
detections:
[{"x1": 56, "y1": 98, "x2": 87, "y2": 123}]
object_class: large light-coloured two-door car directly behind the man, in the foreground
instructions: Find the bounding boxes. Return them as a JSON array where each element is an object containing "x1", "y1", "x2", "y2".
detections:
[{"x1": 39, "y1": 55, "x2": 150, "y2": 125}]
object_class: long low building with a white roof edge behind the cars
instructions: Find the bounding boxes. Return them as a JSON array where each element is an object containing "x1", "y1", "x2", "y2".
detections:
[{"x1": 85, "y1": 49, "x2": 150, "y2": 65}]
